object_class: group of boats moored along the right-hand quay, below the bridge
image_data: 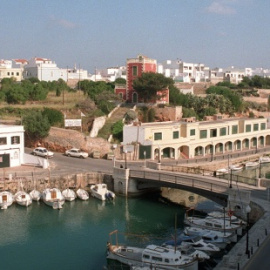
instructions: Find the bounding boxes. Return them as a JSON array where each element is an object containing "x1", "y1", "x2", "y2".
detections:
[{"x1": 107, "y1": 212, "x2": 245, "y2": 270}]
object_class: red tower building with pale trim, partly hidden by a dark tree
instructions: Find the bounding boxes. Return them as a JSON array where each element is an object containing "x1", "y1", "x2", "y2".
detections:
[{"x1": 115, "y1": 55, "x2": 169, "y2": 103}]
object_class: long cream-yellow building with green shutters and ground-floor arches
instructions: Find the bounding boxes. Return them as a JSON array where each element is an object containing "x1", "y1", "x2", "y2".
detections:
[{"x1": 123, "y1": 116, "x2": 270, "y2": 159}]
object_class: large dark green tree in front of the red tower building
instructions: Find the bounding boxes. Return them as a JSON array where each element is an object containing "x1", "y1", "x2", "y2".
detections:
[{"x1": 133, "y1": 72, "x2": 173, "y2": 102}]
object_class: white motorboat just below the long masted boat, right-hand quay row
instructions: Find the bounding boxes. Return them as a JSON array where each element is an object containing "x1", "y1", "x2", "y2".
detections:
[{"x1": 184, "y1": 226, "x2": 237, "y2": 245}]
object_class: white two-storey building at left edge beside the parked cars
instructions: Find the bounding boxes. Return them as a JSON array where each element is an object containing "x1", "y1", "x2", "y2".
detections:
[{"x1": 0, "y1": 125, "x2": 24, "y2": 168}]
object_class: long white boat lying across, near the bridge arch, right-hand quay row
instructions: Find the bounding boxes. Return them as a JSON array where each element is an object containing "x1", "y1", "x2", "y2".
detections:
[{"x1": 184, "y1": 215, "x2": 243, "y2": 235}]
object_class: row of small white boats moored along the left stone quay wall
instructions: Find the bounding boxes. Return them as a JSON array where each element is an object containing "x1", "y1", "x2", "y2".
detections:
[{"x1": 0, "y1": 184, "x2": 115, "y2": 209}]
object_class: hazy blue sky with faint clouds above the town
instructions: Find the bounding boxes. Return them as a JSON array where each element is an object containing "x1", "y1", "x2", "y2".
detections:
[{"x1": 0, "y1": 0, "x2": 270, "y2": 73}]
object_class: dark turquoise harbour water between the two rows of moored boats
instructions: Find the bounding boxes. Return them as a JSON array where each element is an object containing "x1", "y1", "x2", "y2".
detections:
[{"x1": 0, "y1": 195, "x2": 196, "y2": 270}]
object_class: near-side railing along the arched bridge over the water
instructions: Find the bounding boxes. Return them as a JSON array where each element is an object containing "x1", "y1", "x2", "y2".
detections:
[{"x1": 129, "y1": 170, "x2": 229, "y2": 193}]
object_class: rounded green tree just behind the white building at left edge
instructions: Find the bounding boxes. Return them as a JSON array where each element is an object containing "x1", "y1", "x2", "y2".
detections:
[{"x1": 22, "y1": 111, "x2": 51, "y2": 141}]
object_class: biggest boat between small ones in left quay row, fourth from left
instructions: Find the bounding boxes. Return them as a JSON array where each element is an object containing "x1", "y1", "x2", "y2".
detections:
[{"x1": 42, "y1": 188, "x2": 65, "y2": 209}]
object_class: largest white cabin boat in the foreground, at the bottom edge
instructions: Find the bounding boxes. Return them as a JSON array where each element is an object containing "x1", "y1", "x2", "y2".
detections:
[{"x1": 107, "y1": 243, "x2": 198, "y2": 270}]
